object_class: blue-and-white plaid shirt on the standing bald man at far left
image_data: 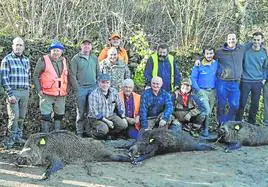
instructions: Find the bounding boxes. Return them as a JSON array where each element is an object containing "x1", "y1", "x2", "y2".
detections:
[{"x1": 1, "y1": 52, "x2": 30, "y2": 96}]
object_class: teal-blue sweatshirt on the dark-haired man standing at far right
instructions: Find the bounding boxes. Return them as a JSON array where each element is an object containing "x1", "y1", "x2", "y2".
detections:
[{"x1": 241, "y1": 45, "x2": 268, "y2": 82}]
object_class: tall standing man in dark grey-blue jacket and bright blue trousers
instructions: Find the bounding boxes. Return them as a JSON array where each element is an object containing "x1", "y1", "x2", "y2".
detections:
[{"x1": 216, "y1": 34, "x2": 244, "y2": 125}]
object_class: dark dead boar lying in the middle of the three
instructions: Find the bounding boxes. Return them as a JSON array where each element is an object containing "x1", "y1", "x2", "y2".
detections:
[{"x1": 129, "y1": 128, "x2": 215, "y2": 164}]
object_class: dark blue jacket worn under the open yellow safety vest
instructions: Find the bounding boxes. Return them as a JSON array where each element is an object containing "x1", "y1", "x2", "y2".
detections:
[{"x1": 144, "y1": 57, "x2": 181, "y2": 92}]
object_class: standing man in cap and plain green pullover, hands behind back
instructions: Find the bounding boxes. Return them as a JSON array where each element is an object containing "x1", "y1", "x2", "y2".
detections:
[{"x1": 69, "y1": 39, "x2": 100, "y2": 137}]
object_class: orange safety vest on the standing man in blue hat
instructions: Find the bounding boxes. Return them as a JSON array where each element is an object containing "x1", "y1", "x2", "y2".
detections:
[{"x1": 39, "y1": 55, "x2": 68, "y2": 96}]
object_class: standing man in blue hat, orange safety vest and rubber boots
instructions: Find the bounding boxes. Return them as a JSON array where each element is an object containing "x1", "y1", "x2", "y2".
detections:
[{"x1": 33, "y1": 41, "x2": 68, "y2": 133}]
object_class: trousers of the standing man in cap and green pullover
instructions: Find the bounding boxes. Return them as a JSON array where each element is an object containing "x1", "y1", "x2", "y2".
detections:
[{"x1": 75, "y1": 87, "x2": 96, "y2": 134}]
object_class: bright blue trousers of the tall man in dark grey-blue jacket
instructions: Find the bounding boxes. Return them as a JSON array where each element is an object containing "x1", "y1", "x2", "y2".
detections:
[{"x1": 216, "y1": 80, "x2": 240, "y2": 124}]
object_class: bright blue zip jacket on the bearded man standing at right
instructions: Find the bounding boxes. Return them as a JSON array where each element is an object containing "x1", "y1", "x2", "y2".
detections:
[{"x1": 191, "y1": 60, "x2": 218, "y2": 92}]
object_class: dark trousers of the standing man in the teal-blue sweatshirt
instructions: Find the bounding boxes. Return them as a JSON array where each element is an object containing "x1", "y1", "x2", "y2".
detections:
[{"x1": 236, "y1": 81, "x2": 262, "y2": 124}]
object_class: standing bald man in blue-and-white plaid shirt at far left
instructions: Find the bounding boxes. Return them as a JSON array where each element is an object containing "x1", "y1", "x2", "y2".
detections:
[{"x1": 1, "y1": 37, "x2": 30, "y2": 148}]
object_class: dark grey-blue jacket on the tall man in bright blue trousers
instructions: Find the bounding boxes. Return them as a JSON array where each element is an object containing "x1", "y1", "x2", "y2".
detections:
[{"x1": 216, "y1": 44, "x2": 245, "y2": 81}]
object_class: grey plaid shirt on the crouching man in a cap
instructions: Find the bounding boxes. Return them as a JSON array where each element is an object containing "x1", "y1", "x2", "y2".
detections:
[{"x1": 88, "y1": 88, "x2": 125, "y2": 120}]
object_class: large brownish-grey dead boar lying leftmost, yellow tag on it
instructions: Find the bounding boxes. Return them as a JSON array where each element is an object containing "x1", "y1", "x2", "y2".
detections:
[{"x1": 20, "y1": 130, "x2": 130, "y2": 179}]
